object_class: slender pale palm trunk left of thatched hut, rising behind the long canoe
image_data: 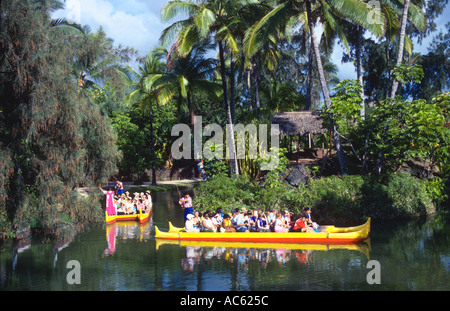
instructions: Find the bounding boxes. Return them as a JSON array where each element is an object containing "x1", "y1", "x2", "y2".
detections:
[{"x1": 218, "y1": 40, "x2": 239, "y2": 176}]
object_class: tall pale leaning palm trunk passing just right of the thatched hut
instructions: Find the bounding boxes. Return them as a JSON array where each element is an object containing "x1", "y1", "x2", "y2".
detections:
[{"x1": 305, "y1": 0, "x2": 346, "y2": 174}]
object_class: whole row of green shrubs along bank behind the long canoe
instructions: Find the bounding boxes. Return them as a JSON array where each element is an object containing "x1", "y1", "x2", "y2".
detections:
[{"x1": 194, "y1": 174, "x2": 435, "y2": 225}]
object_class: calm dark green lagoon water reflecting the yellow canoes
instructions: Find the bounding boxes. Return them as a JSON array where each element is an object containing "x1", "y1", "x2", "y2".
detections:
[{"x1": 0, "y1": 190, "x2": 450, "y2": 291}]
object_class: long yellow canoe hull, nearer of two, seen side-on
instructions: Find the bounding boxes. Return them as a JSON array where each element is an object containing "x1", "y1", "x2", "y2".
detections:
[{"x1": 155, "y1": 218, "x2": 370, "y2": 244}]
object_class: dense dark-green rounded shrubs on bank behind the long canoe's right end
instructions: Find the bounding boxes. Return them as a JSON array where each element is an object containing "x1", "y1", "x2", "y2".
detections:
[{"x1": 284, "y1": 174, "x2": 434, "y2": 224}]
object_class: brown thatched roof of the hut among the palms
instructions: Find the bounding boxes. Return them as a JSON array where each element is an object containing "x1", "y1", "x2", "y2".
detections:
[{"x1": 272, "y1": 111, "x2": 326, "y2": 136}]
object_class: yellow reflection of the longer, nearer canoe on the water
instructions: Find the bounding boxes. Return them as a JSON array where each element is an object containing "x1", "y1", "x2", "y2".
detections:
[{"x1": 156, "y1": 239, "x2": 370, "y2": 259}]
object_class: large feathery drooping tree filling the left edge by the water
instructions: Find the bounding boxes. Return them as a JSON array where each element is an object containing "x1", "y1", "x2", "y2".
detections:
[{"x1": 0, "y1": 1, "x2": 120, "y2": 234}]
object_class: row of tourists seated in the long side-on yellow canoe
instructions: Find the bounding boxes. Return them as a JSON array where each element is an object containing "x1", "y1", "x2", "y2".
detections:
[{"x1": 184, "y1": 207, "x2": 320, "y2": 232}]
